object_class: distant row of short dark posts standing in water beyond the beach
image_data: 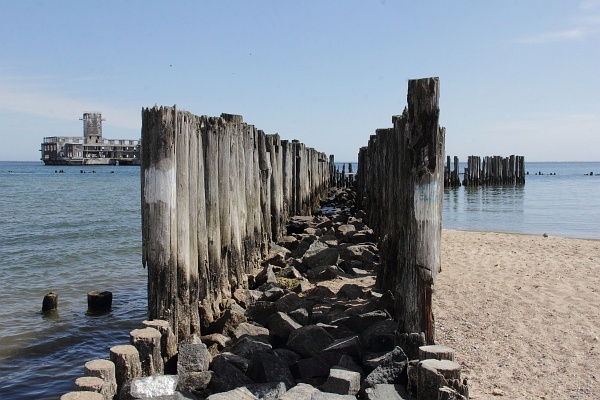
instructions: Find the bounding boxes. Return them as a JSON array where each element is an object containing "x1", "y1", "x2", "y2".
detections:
[{"x1": 444, "y1": 155, "x2": 525, "y2": 187}]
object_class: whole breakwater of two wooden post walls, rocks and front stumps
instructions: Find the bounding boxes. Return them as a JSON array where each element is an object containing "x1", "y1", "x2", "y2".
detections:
[{"x1": 70, "y1": 78, "x2": 469, "y2": 400}]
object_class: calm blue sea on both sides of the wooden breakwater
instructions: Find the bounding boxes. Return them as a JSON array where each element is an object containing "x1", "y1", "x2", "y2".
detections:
[{"x1": 0, "y1": 162, "x2": 600, "y2": 399}]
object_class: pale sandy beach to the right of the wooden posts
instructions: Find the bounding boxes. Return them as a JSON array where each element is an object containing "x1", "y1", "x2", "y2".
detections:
[{"x1": 433, "y1": 230, "x2": 600, "y2": 399}]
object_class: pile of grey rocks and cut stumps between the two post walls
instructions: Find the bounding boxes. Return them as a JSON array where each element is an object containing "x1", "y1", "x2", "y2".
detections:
[{"x1": 63, "y1": 189, "x2": 468, "y2": 400}]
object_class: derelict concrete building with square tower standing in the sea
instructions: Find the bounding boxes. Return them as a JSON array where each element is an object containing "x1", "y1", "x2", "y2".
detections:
[{"x1": 40, "y1": 112, "x2": 141, "y2": 165}]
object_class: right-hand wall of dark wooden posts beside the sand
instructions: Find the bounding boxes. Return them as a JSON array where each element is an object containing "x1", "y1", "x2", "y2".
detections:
[{"x1": 355, "y1": 78, "x2": 445, "y2": 346}]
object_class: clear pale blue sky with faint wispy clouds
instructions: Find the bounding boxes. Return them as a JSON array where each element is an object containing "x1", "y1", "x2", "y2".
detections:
[{"x1": 0, "y1": 0, "x2": 600, "y2": 161}]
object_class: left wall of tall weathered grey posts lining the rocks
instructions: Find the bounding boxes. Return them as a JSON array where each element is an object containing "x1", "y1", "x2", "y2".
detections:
[{"x1": 141, "y1": 106, "x2": 330, "y2": 339}]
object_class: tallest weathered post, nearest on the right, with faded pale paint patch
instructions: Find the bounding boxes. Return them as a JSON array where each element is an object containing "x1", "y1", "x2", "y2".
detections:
[{"x1": 394, "y1": 78, "x2": 445, "y2": 344}]
